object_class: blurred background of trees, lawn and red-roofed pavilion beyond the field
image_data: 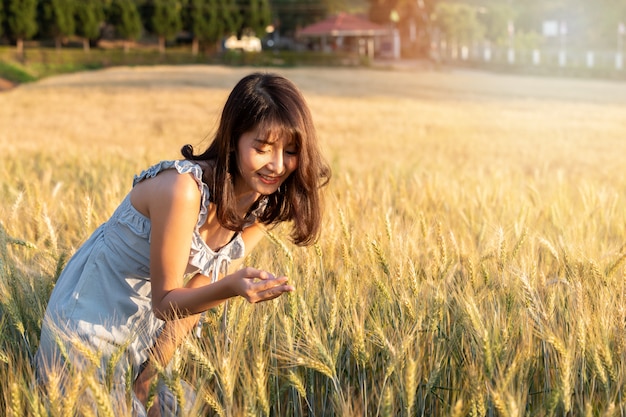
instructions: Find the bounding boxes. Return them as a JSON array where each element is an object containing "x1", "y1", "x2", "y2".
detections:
[{"x1": 0, "y1": 0, "x2": 626, "y2": 82}]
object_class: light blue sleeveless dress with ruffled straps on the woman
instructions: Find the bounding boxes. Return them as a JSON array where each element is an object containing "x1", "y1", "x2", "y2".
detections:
[{"x1": 36, "y1": 160, "x2": 264, "y2": 414}]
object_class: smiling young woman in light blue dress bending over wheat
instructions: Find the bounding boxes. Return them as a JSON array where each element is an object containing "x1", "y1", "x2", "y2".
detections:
[{"x1": 37, "y1": 73, "x2": 330, "y2": 415}]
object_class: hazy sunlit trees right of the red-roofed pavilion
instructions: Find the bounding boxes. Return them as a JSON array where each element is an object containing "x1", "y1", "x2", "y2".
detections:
[{"x1": 368, "y1": 0, "x2": 626, "y2": 57}]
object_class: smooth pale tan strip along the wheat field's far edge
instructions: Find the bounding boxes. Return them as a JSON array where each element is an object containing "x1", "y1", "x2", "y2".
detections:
[{"x1": 20, "y1": 65, "x2": 626, "y2": 104}]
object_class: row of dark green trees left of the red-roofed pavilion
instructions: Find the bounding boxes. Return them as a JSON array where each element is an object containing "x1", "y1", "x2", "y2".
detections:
[{"x1": 0, "y1": 0, "x2": 325, "y2": 53}]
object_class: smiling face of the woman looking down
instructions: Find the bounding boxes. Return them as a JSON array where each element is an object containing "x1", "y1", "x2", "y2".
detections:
[{"x1": 235, "y1": 130, "x2": 298, "y2": 195}]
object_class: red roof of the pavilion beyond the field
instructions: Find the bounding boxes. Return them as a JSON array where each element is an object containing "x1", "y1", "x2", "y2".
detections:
[{"x1": 298, "y1": 13, "x2": 389, "y2": 36}]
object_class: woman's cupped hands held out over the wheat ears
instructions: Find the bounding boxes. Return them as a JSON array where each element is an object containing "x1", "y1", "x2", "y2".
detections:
[{"x1": 223, "y1": 267, "x2": 295, "y2": 303}]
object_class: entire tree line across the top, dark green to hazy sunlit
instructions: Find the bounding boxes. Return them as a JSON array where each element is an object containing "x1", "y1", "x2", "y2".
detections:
[{"x1": 0, "y1": 0, "x2": 626, "y2": 60}]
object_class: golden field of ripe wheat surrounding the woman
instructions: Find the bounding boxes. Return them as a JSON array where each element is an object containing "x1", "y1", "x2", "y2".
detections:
[{"x1": 0, "y1": 66, "x2": 626, "y2": 417}]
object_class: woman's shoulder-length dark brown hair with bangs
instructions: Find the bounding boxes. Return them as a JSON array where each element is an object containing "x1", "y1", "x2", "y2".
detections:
[{"x1": 181, "y1": 73, "x2": 330, "y2": 245}]
